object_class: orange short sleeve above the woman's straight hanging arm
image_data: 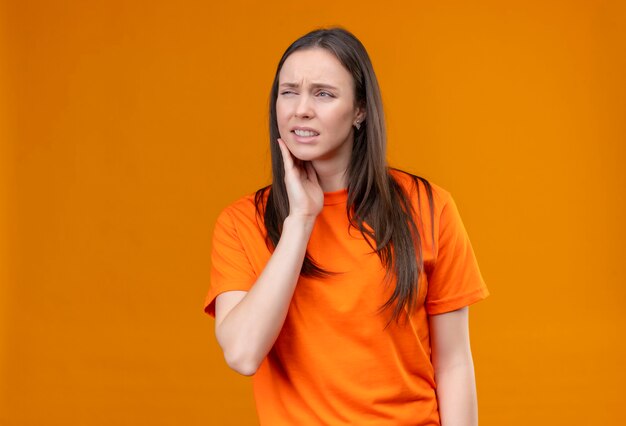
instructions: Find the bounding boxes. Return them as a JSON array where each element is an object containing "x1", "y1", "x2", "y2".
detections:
[{"x1": 425, "y1": 194, "x2": 489, "y2": 315}]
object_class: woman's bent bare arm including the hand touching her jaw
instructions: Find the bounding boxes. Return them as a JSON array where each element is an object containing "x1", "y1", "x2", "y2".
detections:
[{"x1": 215, "y1": 139, "x2": 324, "y2": 376}]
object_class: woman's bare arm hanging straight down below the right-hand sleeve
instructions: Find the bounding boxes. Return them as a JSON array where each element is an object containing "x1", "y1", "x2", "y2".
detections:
[{"x1": 430, "y1": 306, "x2": 478, "y2": 426}]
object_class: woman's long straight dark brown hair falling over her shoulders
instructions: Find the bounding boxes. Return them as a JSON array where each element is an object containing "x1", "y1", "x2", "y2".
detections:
[{"x1": 255, "y1": 28, "x2": 434, "y2": 326}]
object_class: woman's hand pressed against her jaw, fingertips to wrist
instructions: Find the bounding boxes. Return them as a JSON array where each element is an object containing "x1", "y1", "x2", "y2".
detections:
[{"x1": 278, "y1": 138, "x2": 324, "y2": 219}]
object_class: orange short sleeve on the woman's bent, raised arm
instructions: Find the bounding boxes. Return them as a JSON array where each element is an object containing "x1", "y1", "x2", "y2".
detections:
[{"x1": 204, "y1": 209, "x2": 256, "y2": 318}]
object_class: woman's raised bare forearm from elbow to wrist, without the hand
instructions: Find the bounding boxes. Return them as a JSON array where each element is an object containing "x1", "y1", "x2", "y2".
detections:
[{"x1": 216, "y1": 217, "x2": 315, "y2": 375}]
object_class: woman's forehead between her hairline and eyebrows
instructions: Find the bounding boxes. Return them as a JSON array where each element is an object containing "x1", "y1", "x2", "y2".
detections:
[{"x1": 278, "y1": 48, "x2": 352, "y2": 87}]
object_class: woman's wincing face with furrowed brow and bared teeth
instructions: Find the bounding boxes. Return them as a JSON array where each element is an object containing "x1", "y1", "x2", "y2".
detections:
[{"x1": 276, "y1": 48, "x2": 364, "y2": 168}]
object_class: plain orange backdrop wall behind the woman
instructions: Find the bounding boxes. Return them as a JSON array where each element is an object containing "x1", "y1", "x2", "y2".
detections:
[{"x1": 0, "y1": 0, "x2": 626, "y2": 426}]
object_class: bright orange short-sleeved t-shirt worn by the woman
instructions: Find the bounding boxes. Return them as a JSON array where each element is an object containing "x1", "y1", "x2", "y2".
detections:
[{"x1": 205, "y1": 169, "x2": 489, "y2": 426}]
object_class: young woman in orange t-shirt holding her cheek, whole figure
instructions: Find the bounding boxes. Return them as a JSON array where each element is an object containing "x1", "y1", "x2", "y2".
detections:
[{"x1": 205, "y1": 28, "x2": 489, "y2": 426}]
